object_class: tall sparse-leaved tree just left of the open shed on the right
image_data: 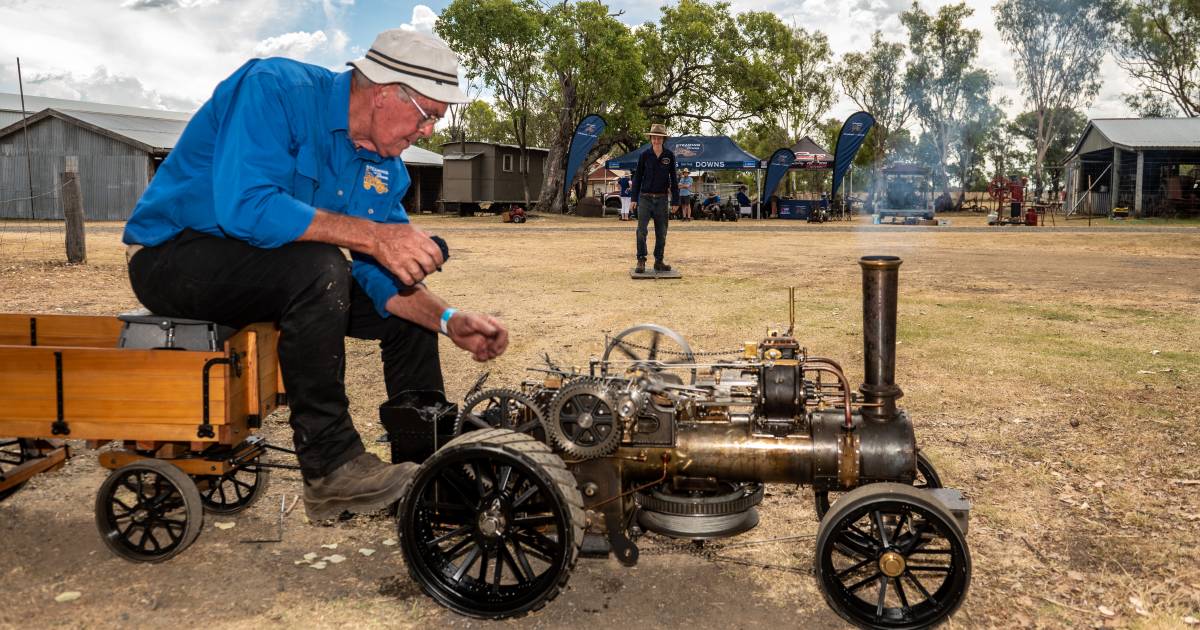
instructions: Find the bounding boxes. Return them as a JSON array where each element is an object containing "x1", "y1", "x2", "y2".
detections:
[{"x1": 994, "y1": 0, "x2": 1117, "y2": 196}]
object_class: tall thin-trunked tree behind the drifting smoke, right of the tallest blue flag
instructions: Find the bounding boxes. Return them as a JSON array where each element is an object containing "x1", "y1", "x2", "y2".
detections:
[{"x1": 900, "y1": 2, "x2": 986, "y2": 194}]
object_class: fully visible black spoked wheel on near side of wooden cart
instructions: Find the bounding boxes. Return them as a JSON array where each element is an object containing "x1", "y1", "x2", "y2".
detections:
[{"x1": 96, "y1": 460, "x2": 204, "y2": 562}]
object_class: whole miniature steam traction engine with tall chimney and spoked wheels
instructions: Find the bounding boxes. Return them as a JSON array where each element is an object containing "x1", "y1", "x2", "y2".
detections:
[{"x1": 398, "y1": 256, "x2": 971, "y2": 628}]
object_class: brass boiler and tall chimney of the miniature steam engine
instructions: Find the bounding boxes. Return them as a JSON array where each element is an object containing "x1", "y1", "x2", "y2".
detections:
[{"x1": 614, "y1": 256, "x2": 917, "y2": 490}]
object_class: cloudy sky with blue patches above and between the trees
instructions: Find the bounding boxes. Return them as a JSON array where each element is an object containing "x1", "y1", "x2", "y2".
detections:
[{"x1": 0, "y1": 0, "x2": 1134, "y2": 118}]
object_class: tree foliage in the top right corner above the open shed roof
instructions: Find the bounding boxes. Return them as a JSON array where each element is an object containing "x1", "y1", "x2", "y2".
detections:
[{"x1": 1116, "y1": 0, "x2": 1200, "y2": 118}]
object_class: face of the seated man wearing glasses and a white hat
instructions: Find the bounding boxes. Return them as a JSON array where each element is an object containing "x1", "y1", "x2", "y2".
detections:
[{"x1": 368, "y1": 84, "x2": 450, "y2": 157}]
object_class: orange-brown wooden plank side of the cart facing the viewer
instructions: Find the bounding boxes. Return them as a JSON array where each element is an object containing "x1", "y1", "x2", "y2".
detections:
[{"x1": 0, "y1": 346, "x2": 226, "y2": 429}]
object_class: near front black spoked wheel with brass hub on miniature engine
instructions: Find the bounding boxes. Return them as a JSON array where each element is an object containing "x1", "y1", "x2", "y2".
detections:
[{"x1": 815, "y1": 484, "x2": 971, "y2": 629}]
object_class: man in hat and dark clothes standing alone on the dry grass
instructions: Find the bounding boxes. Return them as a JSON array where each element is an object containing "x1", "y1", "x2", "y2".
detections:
[{"x1": 630, "y1": 125, "x2": 679, "y2": 274}]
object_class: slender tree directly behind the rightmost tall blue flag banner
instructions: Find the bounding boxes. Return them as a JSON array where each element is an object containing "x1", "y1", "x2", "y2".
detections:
[{"x1": 829, "y1": 31, "x2": 913, "y2": 203}]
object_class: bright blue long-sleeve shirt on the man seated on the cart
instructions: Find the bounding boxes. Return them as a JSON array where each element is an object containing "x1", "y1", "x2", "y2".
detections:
[{"x1": 122, "y1": 59, "x2": 410, "y2": 317}]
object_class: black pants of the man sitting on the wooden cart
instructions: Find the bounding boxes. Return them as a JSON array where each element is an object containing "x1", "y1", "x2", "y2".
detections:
[{"x1": 130, "y1": 229, "x2": 444, "y2": 479}]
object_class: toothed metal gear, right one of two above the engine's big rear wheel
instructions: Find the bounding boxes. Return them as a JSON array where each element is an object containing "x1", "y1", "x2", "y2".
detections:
[{"x1": 545, "y1": 378, "x2": 620, "y2": 460}]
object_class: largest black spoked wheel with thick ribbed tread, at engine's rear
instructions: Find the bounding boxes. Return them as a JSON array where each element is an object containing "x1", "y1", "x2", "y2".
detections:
[{"x1": 398, "y1": 428, "x2": 584, "y2": 619}]
